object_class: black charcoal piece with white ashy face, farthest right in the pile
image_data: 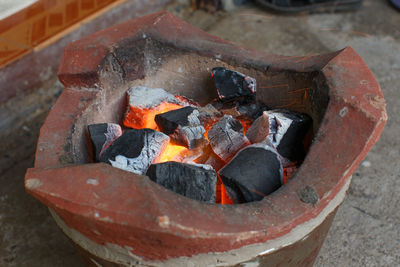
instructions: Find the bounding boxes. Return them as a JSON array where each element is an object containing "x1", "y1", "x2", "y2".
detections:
[{"x1": 264, "y1": 109, "x2": 312, "y2": 162}]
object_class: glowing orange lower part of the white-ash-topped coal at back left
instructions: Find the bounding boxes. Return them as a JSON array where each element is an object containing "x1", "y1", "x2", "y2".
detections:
[{"x1": 124, "y1": 102, "x2": 182, "y2": 130}]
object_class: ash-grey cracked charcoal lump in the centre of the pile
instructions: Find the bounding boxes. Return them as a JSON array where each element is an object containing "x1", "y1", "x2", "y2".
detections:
[{"x1": 208, "y1": 115, "x2": 250, "y2": 161}]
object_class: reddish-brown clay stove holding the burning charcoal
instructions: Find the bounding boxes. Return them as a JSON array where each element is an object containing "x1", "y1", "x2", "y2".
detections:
[{"x1": 25, "y1": 12, "x2": 387, "y2": 266}]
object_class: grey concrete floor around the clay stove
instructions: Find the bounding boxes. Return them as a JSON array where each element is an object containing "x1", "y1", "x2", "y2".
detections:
[{"x1": 0, "y1": 0, "x2": 400, "y2": 266}]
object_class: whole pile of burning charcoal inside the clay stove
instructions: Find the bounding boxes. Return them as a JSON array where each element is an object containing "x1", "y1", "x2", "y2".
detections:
[{"x1": 88, "y1": 67, "x2": 312, "y2": 204}]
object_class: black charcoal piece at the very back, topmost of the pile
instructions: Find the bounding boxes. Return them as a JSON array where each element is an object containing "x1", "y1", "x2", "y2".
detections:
[{"x1": 212, "y1": 67, "x2": 257, "y2": 102}]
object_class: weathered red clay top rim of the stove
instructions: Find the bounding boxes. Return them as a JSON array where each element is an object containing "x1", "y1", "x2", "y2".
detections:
[{"x1": 26, "y1": 12, "x2": 386, "y2": 260}]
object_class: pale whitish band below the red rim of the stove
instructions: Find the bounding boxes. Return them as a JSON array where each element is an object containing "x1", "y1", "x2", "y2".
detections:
[{"x1": 49, "y1": 176, "x2": 352, "y2": 266}]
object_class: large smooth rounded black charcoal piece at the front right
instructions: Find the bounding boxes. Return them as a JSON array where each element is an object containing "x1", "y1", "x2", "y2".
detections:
[{"x1": 218, "y1": 144, "x2": 283, "y2": 203}]
